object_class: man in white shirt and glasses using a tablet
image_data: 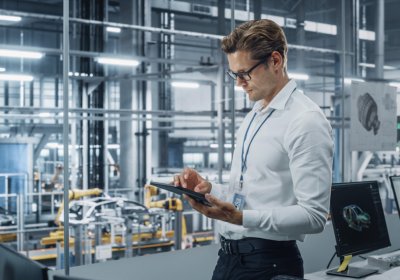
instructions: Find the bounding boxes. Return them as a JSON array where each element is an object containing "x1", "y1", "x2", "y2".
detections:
[{"x1": 174, "y1": 19, "x2": 333, "y2": 279}]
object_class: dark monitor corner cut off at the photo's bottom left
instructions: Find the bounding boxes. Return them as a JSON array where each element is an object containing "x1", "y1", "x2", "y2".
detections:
[{"x1": 0, "y1": 244, "x2": 48, "y2": 280}]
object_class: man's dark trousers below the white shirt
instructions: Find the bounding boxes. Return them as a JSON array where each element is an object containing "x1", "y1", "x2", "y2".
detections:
[{"x1": 212, "y1": 238, "x2": 304, "y2": 280}]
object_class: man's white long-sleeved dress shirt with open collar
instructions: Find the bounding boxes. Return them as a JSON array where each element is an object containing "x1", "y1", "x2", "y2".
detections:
[{"x1": 211, "y1": 80, "x2": 333, "y2": 241}]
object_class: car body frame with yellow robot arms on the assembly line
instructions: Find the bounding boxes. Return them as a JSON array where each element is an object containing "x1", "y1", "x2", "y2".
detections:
[{"x1": 41, "y1": 186, "x2": 180, "y2": 262}]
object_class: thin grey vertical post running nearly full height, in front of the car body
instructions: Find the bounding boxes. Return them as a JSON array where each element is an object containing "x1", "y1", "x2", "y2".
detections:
[{"x1": 63, "y1": 0, "x2": 69, "y2": 275}]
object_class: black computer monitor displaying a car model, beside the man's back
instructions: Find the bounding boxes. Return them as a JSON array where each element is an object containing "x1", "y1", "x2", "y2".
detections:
[{"x1": 327, "y1": 181, "x2": 390, "y2": 278}]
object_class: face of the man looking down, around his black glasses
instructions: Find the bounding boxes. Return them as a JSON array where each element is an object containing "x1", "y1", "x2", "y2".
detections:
[{"x1": 227, "y1": 51, "x2": 276, "y2": 102}]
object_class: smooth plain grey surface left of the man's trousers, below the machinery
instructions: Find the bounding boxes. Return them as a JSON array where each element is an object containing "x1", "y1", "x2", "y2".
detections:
[{"x1": 49, "y1": 244, "x2": 219, "y2": 280}]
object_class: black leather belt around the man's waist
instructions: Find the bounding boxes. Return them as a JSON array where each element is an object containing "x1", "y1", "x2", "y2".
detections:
[{"x1": 220, "y1": 236, "x2": 296, "y2": 255}]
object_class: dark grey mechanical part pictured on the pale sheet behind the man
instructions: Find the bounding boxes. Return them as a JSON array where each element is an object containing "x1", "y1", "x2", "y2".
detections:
[{"x1": 357, "y1": 92, "x2": 380, "y2": 135}]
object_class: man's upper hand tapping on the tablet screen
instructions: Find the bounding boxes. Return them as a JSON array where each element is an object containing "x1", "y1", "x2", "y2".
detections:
[{"x1": 173, "y1": 168, "x2": 212, "y2": 194}]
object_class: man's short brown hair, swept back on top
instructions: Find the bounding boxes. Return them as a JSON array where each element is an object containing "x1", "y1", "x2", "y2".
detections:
[{"x1": 221, "y1": 19, "x2": 288, "y2": 68}]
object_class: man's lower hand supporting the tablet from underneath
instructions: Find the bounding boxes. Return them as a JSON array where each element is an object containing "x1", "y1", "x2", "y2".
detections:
[{"x1": 185, "y1": 194, "x2": 243, "y2": 225}]
